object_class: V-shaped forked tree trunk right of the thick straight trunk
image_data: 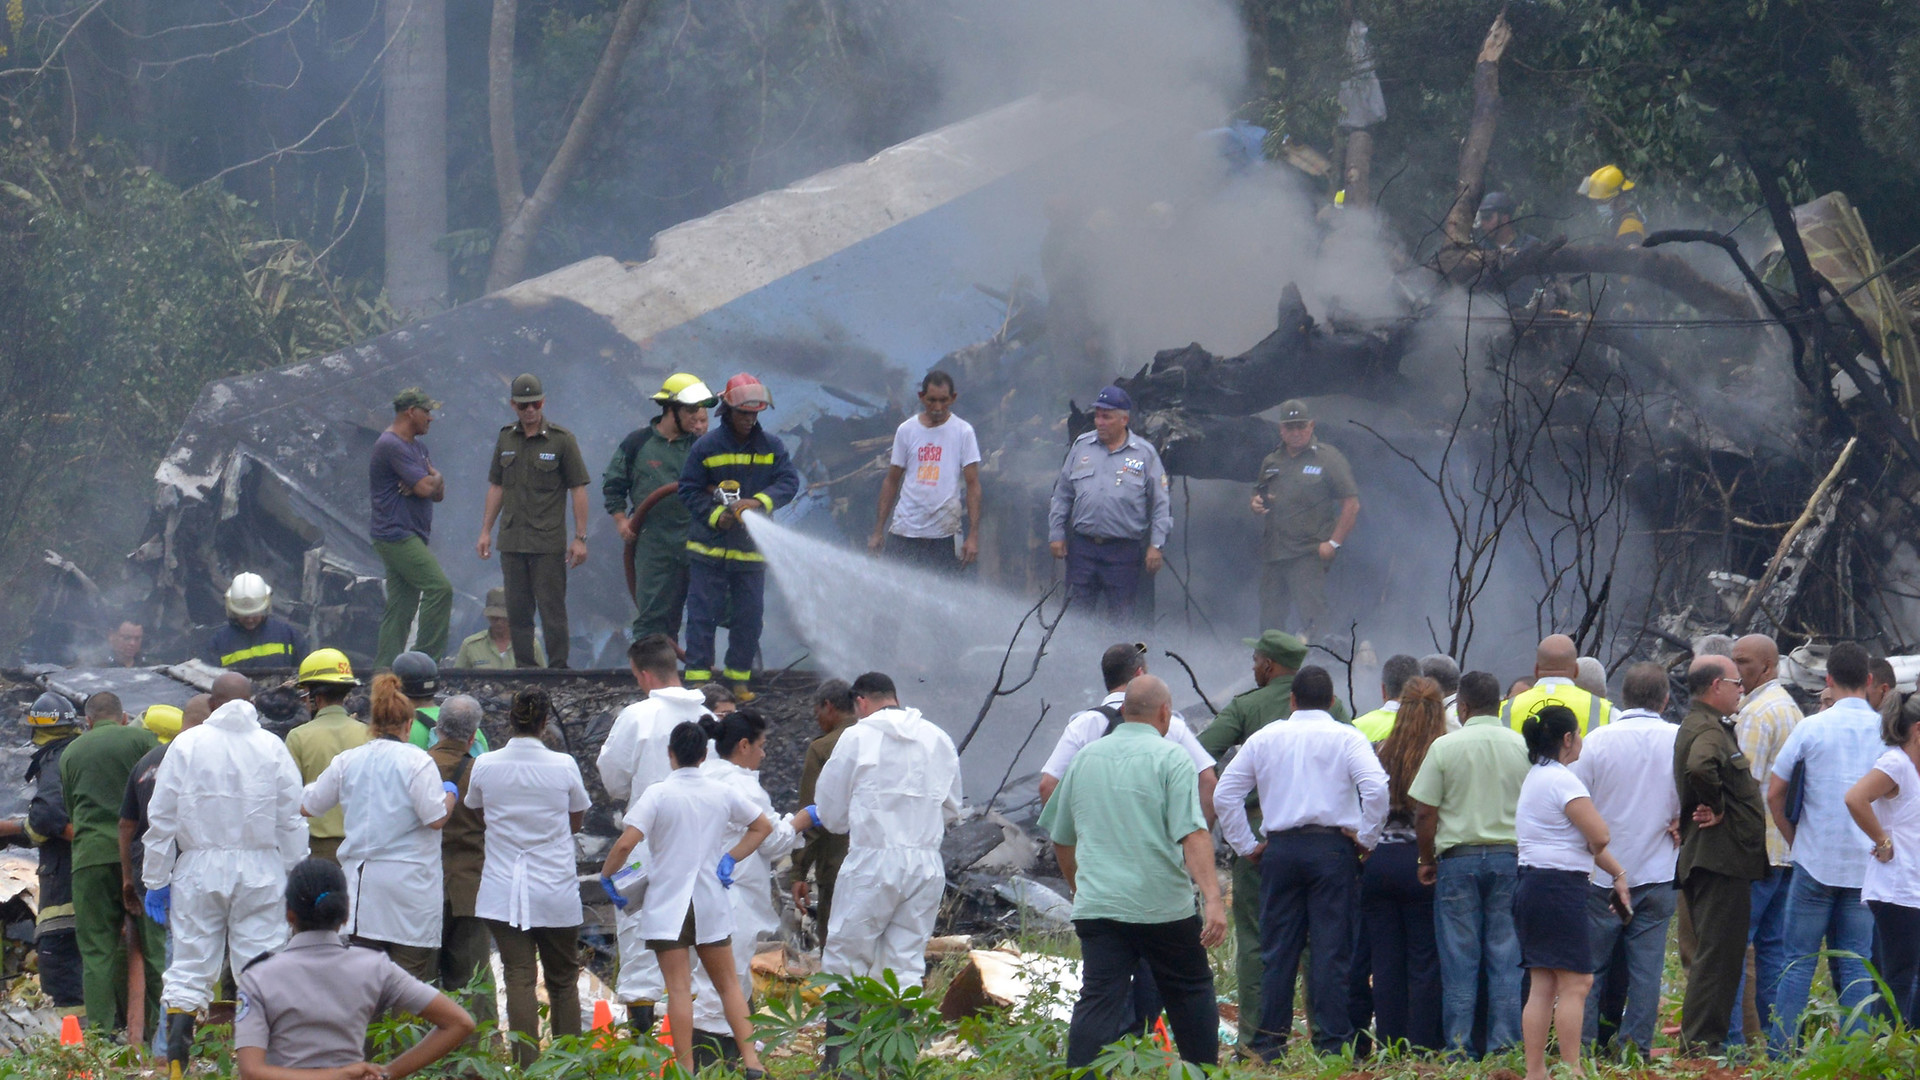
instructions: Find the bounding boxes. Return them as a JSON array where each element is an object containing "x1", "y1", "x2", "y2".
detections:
[{"x1": 486, "y1": 0, "x2": 653, "y2": 292}]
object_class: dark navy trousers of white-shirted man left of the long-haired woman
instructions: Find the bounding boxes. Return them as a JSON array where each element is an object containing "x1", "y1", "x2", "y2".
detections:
[{"x1": 1250, "y1": 828, "x2": 1359, "y2": 1061}]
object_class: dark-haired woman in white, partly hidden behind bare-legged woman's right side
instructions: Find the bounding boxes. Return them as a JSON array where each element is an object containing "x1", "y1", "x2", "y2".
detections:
[{"x1": 693, "y1": 709, "x2": 803, "y2": 1068}]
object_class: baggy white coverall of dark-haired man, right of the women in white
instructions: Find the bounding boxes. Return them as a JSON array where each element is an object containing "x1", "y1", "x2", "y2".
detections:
[{"x1": 814, "y1": 705, "x2": 960, "y2": 986}]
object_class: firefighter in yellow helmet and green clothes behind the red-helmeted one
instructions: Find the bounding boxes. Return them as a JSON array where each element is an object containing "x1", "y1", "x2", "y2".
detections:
[{"x1": 601, "y1": 373, "x2": 718, "y2": 642}]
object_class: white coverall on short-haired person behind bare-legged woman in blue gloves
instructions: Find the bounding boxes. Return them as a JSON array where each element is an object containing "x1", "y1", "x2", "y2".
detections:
[{"x1": 595, "y1": 686, "x2": 707, "y2": 1005}]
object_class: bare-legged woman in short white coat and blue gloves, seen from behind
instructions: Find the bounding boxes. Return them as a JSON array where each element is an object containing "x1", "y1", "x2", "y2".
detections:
[{"x1": 601, "y1": 723, "x2": 774, "y2": 1080}]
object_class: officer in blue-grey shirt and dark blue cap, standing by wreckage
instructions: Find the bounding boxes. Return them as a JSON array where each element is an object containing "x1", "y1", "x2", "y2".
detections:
[{"x1": 1046, "y1": 386, "x2": 1173, "y2": 623}]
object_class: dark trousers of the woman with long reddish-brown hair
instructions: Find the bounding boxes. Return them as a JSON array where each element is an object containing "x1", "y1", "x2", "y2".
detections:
[{"x1": 1359, "y1": 842, "x2": 1446, "y2": 1049}]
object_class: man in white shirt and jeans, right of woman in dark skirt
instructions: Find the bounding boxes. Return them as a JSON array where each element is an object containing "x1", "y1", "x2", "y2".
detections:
[{"x1": 1572, "y1": 663, "x2": 1680, "y2": 1061}]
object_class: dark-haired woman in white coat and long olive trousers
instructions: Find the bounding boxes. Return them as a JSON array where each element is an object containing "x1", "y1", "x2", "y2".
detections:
[{"x1": 467, "y1": 690, "x2": 591, "y2": 1068}]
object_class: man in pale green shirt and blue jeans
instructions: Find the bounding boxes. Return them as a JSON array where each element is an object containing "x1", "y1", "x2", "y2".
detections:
[{"x1": 1407, "y1": 671, "x2": 1528, "y2": 1057}]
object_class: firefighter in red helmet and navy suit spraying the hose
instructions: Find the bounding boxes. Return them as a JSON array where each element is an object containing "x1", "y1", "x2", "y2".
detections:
[{"x1": 680, "y1": 373, "x2": 801, "y2": 703}]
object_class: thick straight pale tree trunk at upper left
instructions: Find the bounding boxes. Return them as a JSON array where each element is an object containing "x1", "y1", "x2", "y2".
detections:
[{"x1": 380, "y1": 0, "x2": 447, "y2": 315}]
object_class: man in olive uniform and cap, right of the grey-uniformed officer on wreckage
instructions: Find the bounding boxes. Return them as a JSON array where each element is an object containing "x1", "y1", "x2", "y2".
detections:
[{"x1": 1254, "y1": 400, "x2": 1359, "y2": 638}]
